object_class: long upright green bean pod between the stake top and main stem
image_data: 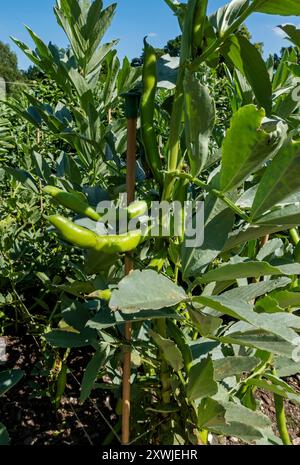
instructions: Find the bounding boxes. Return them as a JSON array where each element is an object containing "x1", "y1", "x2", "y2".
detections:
[{"x1": 141, "y1": 39, "x2": 162, "y2": 183}]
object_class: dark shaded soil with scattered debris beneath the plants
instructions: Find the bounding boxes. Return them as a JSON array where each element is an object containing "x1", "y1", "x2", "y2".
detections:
[{"x1": 0, "y1": 337, "x2": 300, "y2": 445}]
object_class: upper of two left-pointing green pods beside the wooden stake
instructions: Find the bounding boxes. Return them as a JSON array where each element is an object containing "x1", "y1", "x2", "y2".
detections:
[{"x1": 43, "y1": 186, "x2": 101, "y2": 221}]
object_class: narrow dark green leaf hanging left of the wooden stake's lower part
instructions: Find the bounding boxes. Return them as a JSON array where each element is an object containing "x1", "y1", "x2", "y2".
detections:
[{"x1": 80, "y1": 344, "x2": 109, "y2": 402}]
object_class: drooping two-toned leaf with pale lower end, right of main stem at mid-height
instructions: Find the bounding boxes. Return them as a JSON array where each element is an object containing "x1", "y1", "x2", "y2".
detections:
[{"x1": 181, "y1": 195, "x2": 235, "y2": 278}]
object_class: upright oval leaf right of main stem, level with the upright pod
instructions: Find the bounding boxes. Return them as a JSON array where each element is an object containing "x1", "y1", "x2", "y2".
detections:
[{"x1": 184, "y1": 70, "x2": 216, "y2": 176}]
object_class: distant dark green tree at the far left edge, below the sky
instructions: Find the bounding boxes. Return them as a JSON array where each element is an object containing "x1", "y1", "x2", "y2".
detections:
[{"x1": 0, "y1": 41, "x2": 22, "y2": 94}]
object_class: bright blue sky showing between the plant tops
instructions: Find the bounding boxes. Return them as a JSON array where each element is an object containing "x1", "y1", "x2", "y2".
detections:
[{"x1": 0, "y1": 0, "x2": 300, "y2": 69}]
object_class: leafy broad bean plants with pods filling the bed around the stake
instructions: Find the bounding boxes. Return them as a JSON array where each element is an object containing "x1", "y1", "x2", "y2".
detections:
[{"x1": 0, "y1": 0, "x2": 300, "y2": 444}]
